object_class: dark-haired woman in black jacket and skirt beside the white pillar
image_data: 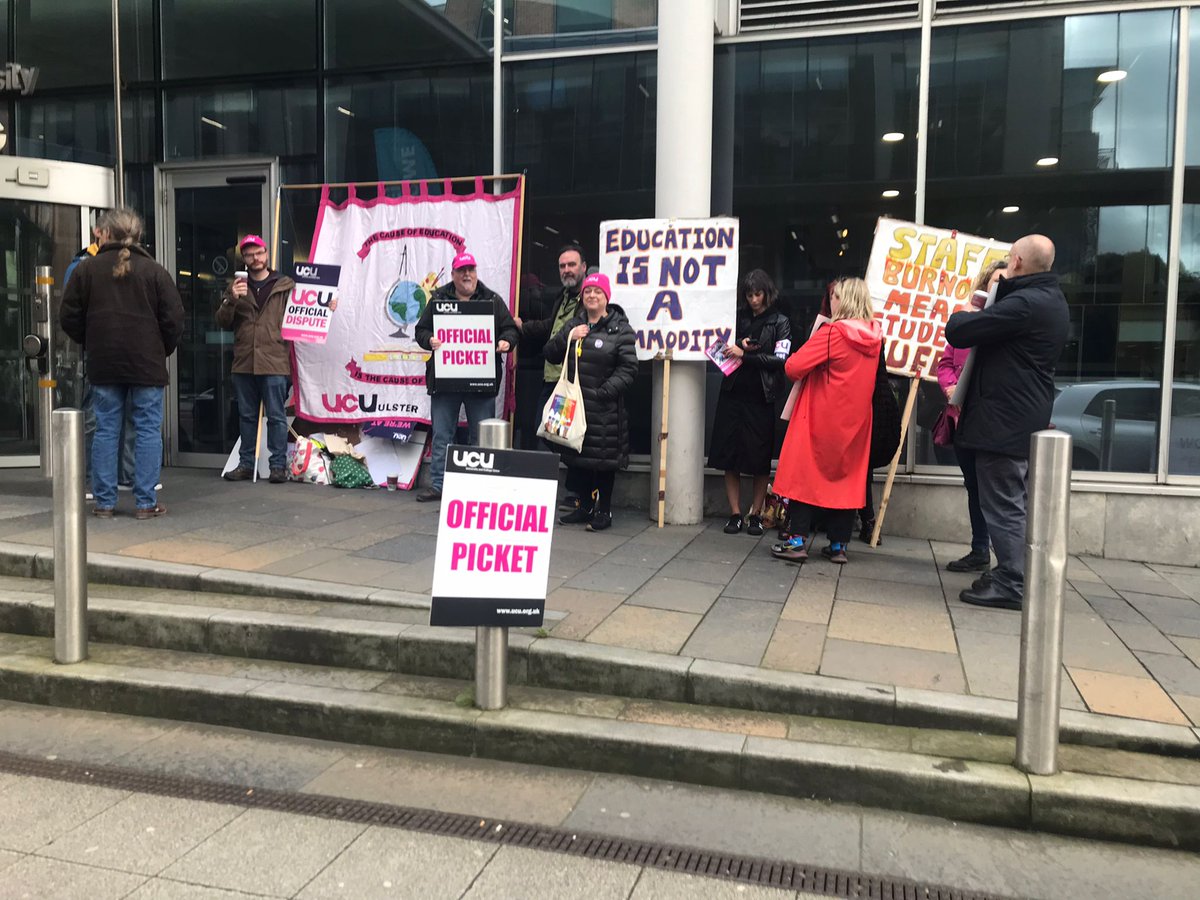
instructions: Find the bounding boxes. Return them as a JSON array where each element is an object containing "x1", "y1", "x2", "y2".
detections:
[{"x1": 708, "y1": 269, "x2": 792, "y2": 535}]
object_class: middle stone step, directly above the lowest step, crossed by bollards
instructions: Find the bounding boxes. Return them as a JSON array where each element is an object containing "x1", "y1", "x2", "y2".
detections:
[{"x1": 0, "y1": 581, "x2": 1200, "y2": 758}]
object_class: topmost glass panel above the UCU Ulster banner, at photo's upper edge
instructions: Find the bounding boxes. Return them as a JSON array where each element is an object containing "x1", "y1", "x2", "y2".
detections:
[{"x1": 325, "y1": 0, "x2": 492, "y2": 68}]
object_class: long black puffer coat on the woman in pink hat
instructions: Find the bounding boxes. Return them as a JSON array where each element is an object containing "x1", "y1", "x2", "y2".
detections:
[{"x1": 542, "y1": 304, "x2": 637, "y2": 472}]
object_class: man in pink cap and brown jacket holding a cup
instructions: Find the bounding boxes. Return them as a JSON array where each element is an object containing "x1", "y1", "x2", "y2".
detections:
[{"x1": 216, "y1": 234, "x2": 295, "y2": 485}]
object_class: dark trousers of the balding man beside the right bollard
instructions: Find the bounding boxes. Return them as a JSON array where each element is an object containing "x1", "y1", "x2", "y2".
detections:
[{"x1": 976, "y1": 450, "x2": 1030, "y2": 599}]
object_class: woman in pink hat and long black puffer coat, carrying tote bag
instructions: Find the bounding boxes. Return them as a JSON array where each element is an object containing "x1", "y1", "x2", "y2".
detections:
[{"x1": 542, "y1": 274, "x2": 637, "y2": 532}]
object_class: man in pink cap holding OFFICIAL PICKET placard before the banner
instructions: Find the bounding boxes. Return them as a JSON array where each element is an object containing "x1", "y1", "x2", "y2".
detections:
[{"x1": 416, "y1": 252, "x2": 520, "y2": 503}]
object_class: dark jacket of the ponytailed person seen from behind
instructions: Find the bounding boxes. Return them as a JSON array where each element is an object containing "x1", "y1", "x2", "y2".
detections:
[{"x1": 61, "y1": 244, "x2": 184, "y2": 386}]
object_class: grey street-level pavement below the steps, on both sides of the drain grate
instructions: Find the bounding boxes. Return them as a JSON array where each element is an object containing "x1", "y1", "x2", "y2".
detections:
[{"x1": 0, "y1": 703, "x2": 1200, "y2": 900}]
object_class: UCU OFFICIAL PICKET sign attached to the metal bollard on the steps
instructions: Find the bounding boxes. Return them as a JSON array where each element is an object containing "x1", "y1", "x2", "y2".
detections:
[{"x1": 430, "y1": 444, "x2": 558, "y2": 628}]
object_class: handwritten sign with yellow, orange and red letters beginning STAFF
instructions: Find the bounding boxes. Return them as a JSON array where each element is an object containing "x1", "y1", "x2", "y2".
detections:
[{"x1": 866, "y1": 218, "x2": 1010, "y2": 378}]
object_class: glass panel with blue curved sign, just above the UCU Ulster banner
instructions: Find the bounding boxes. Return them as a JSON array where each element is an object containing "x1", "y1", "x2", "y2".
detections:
[{"x1": 325, "y1": 64, "x2": 492, "y2": 181}]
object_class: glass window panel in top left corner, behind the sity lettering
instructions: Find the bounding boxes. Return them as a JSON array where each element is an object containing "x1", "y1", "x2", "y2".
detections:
[{"x1": 12, "y1": 0, "x2": 155, "y2": 90}]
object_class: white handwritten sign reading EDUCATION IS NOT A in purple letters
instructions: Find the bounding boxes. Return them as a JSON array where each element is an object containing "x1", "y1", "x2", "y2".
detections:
[{"x1": 600, "y1": 218, "x2": 738, "y2": 361}]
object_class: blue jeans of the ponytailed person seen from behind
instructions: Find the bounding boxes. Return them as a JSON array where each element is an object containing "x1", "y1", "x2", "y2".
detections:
[{"x1": 91, "y1": 384, "x2": 164, "y2": 509}]
